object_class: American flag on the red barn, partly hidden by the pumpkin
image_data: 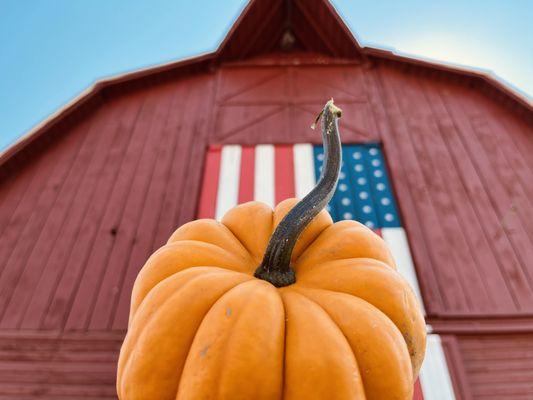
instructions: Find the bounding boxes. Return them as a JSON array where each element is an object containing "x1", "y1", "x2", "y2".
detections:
[{"x1": 198, "y1": 143, "x2": 455, "y2": 400}]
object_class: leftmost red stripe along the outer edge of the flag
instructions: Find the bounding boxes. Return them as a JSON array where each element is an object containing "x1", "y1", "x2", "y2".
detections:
[{"x1": 198, "y1": 146, "x2": 222, "y2": 218}]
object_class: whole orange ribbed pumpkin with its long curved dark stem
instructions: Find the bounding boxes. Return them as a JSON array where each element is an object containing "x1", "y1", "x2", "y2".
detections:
[{"x1": 117, "y1": 100, "x2": 426, "y2": 400}]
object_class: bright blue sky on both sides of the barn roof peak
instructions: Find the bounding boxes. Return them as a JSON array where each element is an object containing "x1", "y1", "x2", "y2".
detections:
[{"x1": 0, "y1": 0, "x2": 533, "y2": 151}]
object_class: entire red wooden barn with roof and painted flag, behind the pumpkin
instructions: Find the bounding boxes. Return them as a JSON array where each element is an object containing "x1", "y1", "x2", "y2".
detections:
[{"x1": 0, "y1": 0, "x2": 533, "y2": 399}]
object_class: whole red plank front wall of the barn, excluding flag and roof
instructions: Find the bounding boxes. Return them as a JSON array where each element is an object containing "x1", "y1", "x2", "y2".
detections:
[{"x1": 0, "y1": 56, "x2": 533, "y2": 398}]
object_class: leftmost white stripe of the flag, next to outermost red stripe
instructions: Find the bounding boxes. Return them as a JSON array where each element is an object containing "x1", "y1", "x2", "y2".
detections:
[{"x1": 215, "y1": 145, "x2": 241, "y2": 220}]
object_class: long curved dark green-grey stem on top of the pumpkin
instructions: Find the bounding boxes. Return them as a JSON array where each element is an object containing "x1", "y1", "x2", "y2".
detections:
[{"x1": 254, "y1": 99, "x2": 341, "y2": 287}]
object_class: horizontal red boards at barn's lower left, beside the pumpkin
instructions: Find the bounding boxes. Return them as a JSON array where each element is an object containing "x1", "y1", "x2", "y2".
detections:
[{"x1": 0, "y1": 333, "x2": 123, "y2": 400}]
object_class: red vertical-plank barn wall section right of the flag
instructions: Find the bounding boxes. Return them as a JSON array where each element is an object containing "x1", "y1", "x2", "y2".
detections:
[{"x1": 368, "y1": 67, "x2": 533, "y2": 317}]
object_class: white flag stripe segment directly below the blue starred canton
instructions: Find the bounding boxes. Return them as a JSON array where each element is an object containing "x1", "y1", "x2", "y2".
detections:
[{"x1": 381, "y1": 228, "x2": 426, "y2": 314}]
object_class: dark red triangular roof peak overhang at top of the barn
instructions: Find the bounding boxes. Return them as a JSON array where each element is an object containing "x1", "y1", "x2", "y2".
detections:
[{"x1": 217, "y1": 0, "x2": 363, "y2": 61}]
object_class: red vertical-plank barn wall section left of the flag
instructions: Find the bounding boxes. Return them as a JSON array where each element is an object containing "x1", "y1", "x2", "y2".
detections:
[{"x1": 0, "y1": 72, "x2": 214, "y2": 331}]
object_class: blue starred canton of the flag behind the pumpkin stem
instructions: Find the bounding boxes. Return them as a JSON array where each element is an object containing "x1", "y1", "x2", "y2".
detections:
[{"x1": 313, "y1": 143, "x2": 401, "y2": 229}]
